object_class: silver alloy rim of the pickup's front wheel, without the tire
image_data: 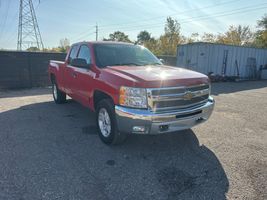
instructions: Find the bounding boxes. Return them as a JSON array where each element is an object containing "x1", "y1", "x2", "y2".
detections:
[{"x1": 98, "y1": 108, "x2": 111, "y2": 137}]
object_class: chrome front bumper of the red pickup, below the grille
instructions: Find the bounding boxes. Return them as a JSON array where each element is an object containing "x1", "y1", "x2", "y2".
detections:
[{"x1": 115, "y1": 97, "x2": 215, "y2": 134}]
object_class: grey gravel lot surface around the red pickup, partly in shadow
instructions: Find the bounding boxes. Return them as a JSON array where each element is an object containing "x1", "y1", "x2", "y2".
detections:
[{"x1": 0, "y1": 81, "x2": 267, "y2": 200}]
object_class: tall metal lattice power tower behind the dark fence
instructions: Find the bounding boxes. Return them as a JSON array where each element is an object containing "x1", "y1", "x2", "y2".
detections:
[{"x1": 17, "y1": 0, "x2": 44, "y2": 50}]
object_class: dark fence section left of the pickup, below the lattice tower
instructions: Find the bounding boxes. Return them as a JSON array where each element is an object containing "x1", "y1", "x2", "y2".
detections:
[{"x1": 0, "y1": 51, "x2": 66, "y2": 89}]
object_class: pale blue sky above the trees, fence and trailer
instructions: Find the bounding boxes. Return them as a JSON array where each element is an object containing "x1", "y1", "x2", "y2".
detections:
[{"x1": 0, "y1": 0, "x2": 267, "y2": 49}]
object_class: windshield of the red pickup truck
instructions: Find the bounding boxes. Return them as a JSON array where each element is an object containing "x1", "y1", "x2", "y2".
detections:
[{"x1": 94, "y1": 44, "x2": 162, "y2": 68}]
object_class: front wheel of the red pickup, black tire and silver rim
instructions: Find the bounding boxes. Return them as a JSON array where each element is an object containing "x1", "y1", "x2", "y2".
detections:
[{"x1": 96, "y1": 99, "x2": 127, "y2": 145}]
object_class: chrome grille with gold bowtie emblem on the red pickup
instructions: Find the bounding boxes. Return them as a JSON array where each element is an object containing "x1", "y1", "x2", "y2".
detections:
[{"x1": 147, "y1": 84, "x2": 210, "y2": 112}]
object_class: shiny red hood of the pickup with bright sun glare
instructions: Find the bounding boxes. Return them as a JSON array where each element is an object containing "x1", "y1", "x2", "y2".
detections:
[{"x1": 105, "y1": 65, "x2": 209, "y2": 88}]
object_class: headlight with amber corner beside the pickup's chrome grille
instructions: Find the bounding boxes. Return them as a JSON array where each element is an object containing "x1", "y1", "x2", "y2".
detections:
[{"x1": 119, "y1": 87, "x2": 147, "y2": 108}]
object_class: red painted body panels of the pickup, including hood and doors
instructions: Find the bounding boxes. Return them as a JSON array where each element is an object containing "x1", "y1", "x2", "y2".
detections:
[{"x1": 48, "y1": 42, "x2": 209, "y2": 110}]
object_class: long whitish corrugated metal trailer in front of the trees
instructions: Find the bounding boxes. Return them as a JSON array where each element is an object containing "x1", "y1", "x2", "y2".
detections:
[{"x1": 177, "y1": 42, "x2": 267, "y2": 79}]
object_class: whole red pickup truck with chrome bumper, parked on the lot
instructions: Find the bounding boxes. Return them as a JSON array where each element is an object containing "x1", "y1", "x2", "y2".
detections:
[{"x1": 48, "y1": 42, "x2": 214, "y2": 144}]
